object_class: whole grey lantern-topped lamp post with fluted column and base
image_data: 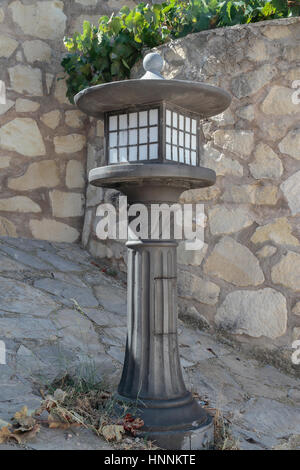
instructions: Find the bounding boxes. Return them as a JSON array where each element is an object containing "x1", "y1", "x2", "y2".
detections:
[{"x1": 75, "y1": 53, "x2": 231, "y2": 449}]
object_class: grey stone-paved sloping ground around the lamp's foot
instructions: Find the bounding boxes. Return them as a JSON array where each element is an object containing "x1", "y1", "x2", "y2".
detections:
[{"x1": 0, "y1": 238, "x2": 300, "y2": 450}]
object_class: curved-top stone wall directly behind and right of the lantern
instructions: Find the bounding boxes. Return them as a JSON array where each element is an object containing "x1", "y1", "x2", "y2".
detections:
[{"x1": 83, "y1": 18, "x2": 300, "y2": 362}]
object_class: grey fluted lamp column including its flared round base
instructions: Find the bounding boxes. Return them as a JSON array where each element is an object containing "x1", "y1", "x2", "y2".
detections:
[{"x1": 117, "y1": 209, "x2": 213, "y2": 449}]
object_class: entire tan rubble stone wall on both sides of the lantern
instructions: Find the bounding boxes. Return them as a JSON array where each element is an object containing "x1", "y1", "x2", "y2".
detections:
[{"x1": 0, "y1": 0, "x2": 300, "y2": 360}]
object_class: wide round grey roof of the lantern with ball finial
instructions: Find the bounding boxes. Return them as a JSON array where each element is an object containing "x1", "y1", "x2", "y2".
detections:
[{"x1": 74, "y1": 53, "x2": 231, "y2": 118}]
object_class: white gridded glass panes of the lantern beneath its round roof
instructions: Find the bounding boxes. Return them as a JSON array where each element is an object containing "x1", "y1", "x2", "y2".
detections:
[{"x1": 106, "y1": 106, "x2": 198, "y2": 166}]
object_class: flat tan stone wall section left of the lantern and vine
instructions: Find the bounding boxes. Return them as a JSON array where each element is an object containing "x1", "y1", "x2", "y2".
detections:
[{"x1": 0, "y1": 0, "x2": 135, "y2": 242}]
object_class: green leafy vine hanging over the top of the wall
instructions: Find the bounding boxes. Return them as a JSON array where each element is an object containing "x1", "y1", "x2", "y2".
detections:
[{"x1": 61, "y1": 0, "x2": 300, "y2": 102}]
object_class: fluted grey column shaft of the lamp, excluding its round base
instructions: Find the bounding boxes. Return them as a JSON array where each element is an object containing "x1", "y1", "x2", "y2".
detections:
[{"x1": 118, "y1": 240, "x2": 188, "y2": 401}]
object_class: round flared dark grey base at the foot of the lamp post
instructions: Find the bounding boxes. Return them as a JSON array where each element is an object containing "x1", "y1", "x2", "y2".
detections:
[{"x1": 115, "y1": 393, "x2": 214, "y2": 450}]
